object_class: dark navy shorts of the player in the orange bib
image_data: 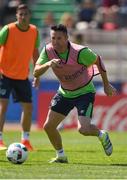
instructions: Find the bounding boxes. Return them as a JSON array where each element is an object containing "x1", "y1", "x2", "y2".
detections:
[{"x1": 0, "y1": 75, "x2": 32, "y2": 103}]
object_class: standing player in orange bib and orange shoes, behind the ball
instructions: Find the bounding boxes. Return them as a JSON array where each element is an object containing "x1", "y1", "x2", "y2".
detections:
[{"x1": 0, "y1": 4, "x2": 40, "y2": 150}]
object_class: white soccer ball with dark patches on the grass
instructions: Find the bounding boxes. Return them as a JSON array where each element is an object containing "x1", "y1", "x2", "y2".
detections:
[{"x1": 6, "y1": 143, "x2": 28, "y2": 164}]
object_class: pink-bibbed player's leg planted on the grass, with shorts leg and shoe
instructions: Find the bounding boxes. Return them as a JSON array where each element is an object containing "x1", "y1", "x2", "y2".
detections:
[{"x1": 44, "y1": 94, "x2": 72, "y2": 163}]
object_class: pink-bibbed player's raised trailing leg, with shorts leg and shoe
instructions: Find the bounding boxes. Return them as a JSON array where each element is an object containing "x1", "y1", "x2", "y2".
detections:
[{"x1": 77, "y1": 93, "x2": 113, "y2": 156}]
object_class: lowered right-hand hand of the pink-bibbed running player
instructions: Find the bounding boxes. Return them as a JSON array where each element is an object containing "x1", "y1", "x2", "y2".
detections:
[{"x1": 104, "y1": 83, "x2": 117, "y2": 96}]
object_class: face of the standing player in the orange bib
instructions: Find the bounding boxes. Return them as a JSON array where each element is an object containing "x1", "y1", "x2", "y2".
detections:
[{"x1": 16, "y1": 9, "x2": 30, "y2": 26}]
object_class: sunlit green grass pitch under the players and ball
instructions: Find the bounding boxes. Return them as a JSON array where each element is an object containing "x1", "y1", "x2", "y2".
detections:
[{"x1": 0, "y1": 130, "x2": 127, "y2": 179}]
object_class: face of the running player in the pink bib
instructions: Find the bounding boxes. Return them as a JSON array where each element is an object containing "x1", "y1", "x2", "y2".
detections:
[{"x1": 50, "y1": 30, "x2": 68, "y2": 53}]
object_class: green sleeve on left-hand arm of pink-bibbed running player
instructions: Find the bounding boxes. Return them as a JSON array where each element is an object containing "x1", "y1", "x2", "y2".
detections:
[{"x1": 36, "y1": 47, "x2": 49, "y2": 65}]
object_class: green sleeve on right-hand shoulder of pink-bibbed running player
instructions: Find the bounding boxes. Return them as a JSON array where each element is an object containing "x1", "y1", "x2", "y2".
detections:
[{"x1": 78, "y1": 48, "x2": 97, "y2": 67}]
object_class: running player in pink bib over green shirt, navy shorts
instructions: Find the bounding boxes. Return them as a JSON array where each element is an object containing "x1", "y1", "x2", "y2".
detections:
[{"x1": 34, "y1": 24, "x2": 116, "y2": 163}]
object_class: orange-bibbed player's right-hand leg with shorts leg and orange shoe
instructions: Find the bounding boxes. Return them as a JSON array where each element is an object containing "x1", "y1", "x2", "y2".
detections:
[{"x1": 12, "y1": 79, "x2": 33, "y2": 151}]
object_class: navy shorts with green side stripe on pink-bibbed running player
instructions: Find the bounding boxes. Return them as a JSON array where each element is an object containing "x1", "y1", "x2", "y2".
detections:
[{"x1": 50, "y1": 93, "x2": 95, "y2": 118}]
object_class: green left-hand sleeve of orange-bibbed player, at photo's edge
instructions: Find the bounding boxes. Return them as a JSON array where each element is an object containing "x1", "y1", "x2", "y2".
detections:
[{"x1": 0, "y1": 25, "x2": 9, "y2": 45}]
